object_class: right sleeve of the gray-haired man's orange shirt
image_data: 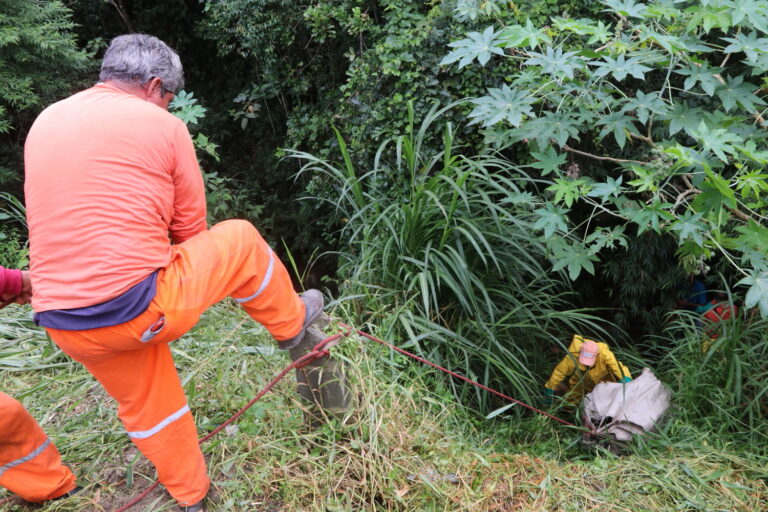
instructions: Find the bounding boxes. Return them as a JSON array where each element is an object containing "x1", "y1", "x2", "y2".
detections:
[{"x1": 170, "y1": 122, "x2": 207, "y2": 244}]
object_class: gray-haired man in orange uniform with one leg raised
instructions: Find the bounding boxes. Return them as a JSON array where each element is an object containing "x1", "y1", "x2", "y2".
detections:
[{"x1": 24, "y1": 34, "x2": 323, "y2": 511}]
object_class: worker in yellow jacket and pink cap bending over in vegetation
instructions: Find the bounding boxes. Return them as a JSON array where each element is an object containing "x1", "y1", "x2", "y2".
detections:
[{"x1": 544, "y1": 334, "x2": 632, "y2": 403}]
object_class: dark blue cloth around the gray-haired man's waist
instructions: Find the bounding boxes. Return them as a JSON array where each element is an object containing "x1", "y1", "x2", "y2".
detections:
[{"x1": 34, "y1": 270, "x2": 157, "y2": 331}]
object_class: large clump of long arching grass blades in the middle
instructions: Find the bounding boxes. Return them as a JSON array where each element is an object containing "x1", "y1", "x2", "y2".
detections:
[{"x1": 290, "y1": 107, "x2": 608, "y2": 412}]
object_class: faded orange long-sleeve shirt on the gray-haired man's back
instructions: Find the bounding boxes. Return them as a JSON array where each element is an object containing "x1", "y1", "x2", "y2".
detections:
[{"x1": 24, "y1": 84, "x2": 206, "y2": 312}]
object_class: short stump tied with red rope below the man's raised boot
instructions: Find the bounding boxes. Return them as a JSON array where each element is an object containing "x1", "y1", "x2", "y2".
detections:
[{"x1": 290, "y1": 324, "x2": 352, "y2": 426}]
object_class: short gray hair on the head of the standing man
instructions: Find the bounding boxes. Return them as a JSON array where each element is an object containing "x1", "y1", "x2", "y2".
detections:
[{"x1": 99, "y1": 34, "x2": 184, "y2": 92}]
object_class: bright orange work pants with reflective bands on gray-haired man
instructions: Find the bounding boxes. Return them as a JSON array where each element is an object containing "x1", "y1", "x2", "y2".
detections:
[{"x1": 47, "y1": 220, "x2": 305, "y2": 505}]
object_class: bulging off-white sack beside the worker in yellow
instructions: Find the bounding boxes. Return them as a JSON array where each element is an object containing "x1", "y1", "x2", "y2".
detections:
[{"x1": 583, "y1": 368, "x2": 671, "y2": 441}]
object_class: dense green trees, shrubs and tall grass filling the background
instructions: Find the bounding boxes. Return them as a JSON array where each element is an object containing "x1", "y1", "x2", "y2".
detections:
[{"x1": 0, "y1": 0, "x2": 768, "y2": 510}]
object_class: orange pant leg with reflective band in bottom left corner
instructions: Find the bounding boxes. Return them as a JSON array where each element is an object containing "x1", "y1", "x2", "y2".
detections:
[{"x1": 0, "y1": 393, "x2": 75, "y2": 503}]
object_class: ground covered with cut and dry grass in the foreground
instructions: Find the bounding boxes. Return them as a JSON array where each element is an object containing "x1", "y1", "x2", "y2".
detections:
[{"x1": 0, "y1": 304, "x2": 768, "y2": 512}]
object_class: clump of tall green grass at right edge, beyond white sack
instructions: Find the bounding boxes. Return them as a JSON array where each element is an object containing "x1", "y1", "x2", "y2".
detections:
[{"x1": 652, "y1": 294, "x2": 768, "y2": 446}]
